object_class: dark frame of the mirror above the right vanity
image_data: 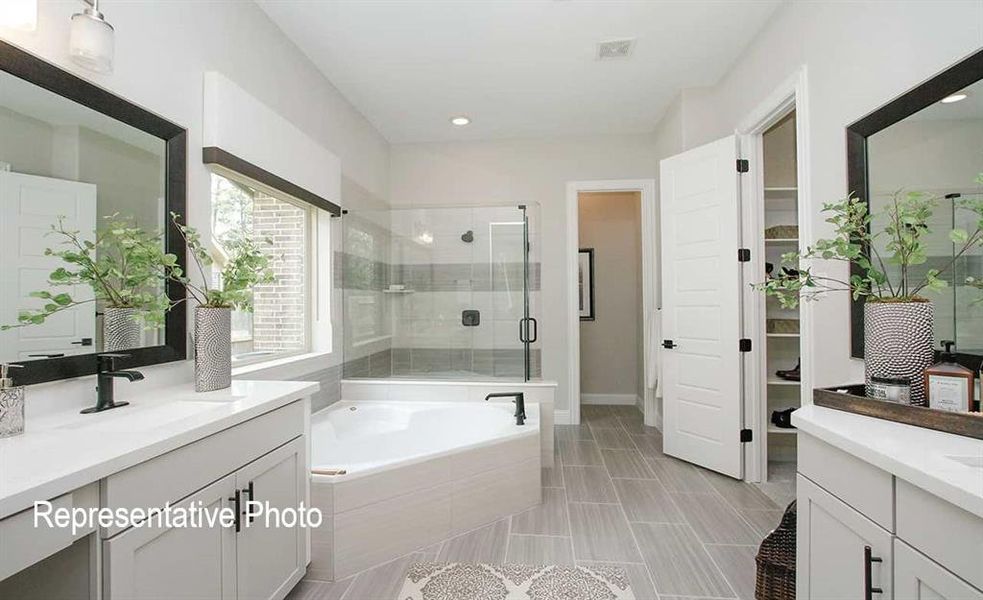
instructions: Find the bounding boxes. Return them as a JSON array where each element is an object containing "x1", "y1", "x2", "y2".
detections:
[{"x1": 846, "y1": 50, "x2": 983, "y2": 370}]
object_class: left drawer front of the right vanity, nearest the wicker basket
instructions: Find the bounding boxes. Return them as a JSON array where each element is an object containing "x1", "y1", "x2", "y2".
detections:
[{"x1": 797, "y1": 435, "x2": 894, "y2": 532}]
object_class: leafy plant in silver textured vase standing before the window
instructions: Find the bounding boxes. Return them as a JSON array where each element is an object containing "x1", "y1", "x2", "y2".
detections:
[{"x1": 168, "y1": 213, "x2": 275, "y2": 392}]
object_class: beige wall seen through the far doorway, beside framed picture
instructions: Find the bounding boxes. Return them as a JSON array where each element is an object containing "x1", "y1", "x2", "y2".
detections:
[{"x1": 578, "y1": 192, "x2": 644, "y2": 404}]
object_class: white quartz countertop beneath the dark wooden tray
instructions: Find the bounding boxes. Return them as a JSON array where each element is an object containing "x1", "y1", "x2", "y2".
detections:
[{"x1": 792, "y1": 405, "x2": 983, "y2": 518}]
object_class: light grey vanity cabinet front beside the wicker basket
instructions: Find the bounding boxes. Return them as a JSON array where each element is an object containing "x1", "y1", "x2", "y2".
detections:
[{"x1": 796, "y1": 427, "x2": 983, "y2": 600}]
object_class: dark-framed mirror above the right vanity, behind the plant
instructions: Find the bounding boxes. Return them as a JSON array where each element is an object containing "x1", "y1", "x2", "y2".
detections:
[{"x1": 846, "y1": 51, "x2": 983, "y2": 369}]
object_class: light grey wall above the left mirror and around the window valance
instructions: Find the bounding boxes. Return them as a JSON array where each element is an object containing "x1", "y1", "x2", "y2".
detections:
[{"x1": 0, "y1": 0, "x2": 389, "y2": 393}]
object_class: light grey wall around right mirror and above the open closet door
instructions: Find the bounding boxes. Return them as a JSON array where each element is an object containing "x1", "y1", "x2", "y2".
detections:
[{"x1": 658, "y1": 0, "x2": 983, "y2": 394}]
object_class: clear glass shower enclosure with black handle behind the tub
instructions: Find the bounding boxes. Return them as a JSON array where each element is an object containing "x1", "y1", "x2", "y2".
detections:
[{"x1": 338, "y1": 205, "x2": 541, "y2": 381}]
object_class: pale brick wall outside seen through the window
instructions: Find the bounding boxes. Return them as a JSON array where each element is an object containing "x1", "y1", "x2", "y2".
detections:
[{"x1": 253, "y1": 191, "x2": 308, "y2": 353}]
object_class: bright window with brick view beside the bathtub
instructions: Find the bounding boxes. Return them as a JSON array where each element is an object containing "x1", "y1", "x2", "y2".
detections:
[{"x1": 211, "y1": 173, "x2": 318, "y2": 364}]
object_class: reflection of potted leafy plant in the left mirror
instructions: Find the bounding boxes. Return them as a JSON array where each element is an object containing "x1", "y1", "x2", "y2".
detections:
[{"x1": 2, "y1": 213, "x2": 177, "y2": 352}]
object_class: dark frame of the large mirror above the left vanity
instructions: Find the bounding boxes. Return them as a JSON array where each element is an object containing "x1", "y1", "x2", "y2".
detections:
[{"x1": 0, "y1": 40, "x2": 188, "y2": 385}]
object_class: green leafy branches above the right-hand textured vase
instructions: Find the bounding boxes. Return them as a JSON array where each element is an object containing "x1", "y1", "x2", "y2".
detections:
[{"x1": 754, "y1": 174, "x2": 983, "y2": 308}]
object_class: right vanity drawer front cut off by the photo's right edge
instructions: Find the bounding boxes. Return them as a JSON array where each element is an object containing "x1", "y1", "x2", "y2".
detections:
[{"x1": 897, "y1": 479, "x2": 983, "y2": 589}]
